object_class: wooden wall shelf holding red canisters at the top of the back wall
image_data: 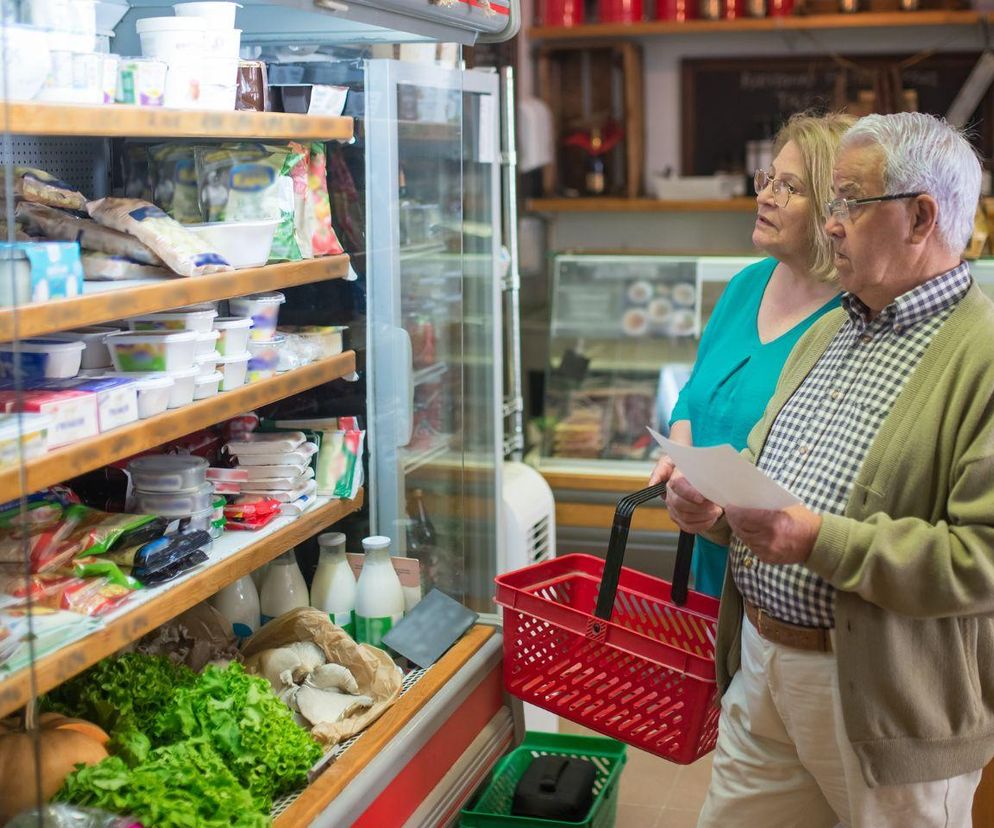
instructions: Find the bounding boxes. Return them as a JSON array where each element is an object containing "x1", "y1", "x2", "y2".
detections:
[{"x1": 528, "y1": 11, "x2": 992, "y2": 41}]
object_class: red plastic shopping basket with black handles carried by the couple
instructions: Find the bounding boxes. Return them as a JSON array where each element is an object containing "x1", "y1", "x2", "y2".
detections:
[{"x1": 495, "y1": 484, "x2": 718, "y2": 764}]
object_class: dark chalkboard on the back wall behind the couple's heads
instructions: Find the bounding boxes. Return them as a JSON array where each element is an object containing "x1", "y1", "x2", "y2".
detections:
[{"x1": 681, "y1": 53, "x2": 994, "y2": 175}]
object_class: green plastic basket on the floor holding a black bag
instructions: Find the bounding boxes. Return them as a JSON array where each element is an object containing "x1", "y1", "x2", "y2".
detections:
[{"x1": 459, "y1": 733, "x2": 626, "y2": 828}]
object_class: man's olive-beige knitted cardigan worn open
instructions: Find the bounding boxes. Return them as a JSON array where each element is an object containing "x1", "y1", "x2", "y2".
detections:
[{"x1": 708, "y1": 284, "x2": 994, "y2": 786}]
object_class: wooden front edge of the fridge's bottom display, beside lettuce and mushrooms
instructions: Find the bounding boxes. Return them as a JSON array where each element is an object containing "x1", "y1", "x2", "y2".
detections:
[{"x1": 273, "y1": 624, "x2": 496, "y2": 828}]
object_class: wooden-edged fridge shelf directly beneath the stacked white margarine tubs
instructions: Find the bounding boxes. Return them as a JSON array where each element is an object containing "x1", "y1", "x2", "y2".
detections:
[{"x1": 0, "y1": 351, "x2": 355, "y2": 503}]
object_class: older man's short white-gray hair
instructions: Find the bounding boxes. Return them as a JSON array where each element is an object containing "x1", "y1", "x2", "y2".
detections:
[{"x1": 840, "y1": 112, "x2": 981, "y2": 254}]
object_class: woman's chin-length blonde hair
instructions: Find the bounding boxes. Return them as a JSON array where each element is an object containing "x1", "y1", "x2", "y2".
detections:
[{"x1": 773, "y1": 112, "x2": 856, "y2": 282}]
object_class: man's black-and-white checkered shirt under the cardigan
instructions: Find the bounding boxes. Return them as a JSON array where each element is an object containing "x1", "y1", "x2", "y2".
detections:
[{"x1": 729, "y1": 262, "x2": 971, "y2": 628}]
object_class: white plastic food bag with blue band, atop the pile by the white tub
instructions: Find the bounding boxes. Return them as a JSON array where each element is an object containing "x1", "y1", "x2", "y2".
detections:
[{"x1": 86, "y1": 198, "x2": 232, "y2": 276}]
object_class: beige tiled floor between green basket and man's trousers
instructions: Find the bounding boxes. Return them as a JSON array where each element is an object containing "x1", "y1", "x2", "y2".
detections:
[{"x1": 559, "y1": 719, "x2": 711, "y2": 828}]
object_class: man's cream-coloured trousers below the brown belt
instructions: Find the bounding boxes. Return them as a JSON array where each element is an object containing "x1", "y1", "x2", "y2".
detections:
[{"x1": 697, "y1": 618, "x2": 981, "y2": 828}]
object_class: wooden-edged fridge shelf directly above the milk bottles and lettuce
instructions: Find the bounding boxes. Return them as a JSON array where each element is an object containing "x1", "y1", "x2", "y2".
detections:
[{"x1": 0, "y1": 491, "x2": 363, "y2": 718}]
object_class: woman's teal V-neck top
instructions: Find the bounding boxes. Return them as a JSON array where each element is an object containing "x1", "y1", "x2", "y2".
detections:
[{"x1": 670, "y1": 259, "x2": 839, "y2": 596}]
